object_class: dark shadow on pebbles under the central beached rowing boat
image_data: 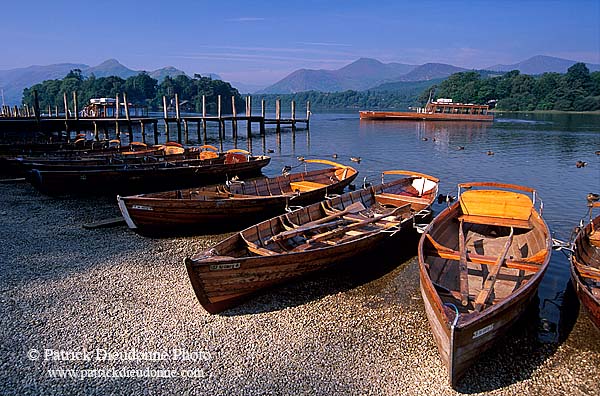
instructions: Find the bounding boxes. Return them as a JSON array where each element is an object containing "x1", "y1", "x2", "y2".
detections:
[{"x1": 219, "y1": 230, "x2": 419, "y2": 316}]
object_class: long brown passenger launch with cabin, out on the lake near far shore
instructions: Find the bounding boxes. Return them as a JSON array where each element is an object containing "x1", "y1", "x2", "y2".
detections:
[{"x1": 359, "y1": 99, "x2": 494, "y2": 121}]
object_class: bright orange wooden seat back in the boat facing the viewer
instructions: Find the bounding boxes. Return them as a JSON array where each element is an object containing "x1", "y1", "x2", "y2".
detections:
[{"x1": 458, "y1": 190, "x2": 533, "y2": 229}]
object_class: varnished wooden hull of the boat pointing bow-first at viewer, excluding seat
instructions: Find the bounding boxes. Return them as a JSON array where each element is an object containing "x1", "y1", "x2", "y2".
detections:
[{"x1": 418, "y1": 184, "x2": 551, "y2": 387}]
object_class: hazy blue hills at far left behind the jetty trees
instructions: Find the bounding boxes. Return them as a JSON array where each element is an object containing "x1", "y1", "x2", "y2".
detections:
[{"x1": 0, "y1": 59, "x2": 185, "y2": 105}]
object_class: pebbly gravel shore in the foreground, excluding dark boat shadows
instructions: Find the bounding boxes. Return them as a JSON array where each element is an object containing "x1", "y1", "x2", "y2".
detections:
[{"x1": 0, "y1": 184, "x2": 600, "y2": 395}]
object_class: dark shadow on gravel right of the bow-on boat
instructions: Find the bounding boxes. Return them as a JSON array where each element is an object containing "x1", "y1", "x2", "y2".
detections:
[{"x1": 456, "y1": 281, "x2": 579, "y2": 394}]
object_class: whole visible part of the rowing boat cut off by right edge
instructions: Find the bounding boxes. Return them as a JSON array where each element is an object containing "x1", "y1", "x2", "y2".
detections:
[{"x1": 571, "y1": 202, "x2": 600, "y2": 329}]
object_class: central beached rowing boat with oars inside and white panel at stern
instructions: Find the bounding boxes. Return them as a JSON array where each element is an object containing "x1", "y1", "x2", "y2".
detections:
[{"x1": 185, "y1": 171, "x2": 438, "y2": 313}]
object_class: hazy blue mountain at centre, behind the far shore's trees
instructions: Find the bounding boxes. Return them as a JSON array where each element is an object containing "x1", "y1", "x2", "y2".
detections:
[{"x1": 260, "y1": 58, "x2": 417, "y2": 93}]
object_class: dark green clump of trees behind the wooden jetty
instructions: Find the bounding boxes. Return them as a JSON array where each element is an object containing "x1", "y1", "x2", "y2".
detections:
[{"x1": 23, "y1": 69, "x2": 244, "y2": 113}]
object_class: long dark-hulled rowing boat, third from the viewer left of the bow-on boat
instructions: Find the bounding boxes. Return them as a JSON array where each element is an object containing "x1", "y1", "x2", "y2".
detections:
[{"x1": 27, "y1": 150, "x2": 271, "y2": 195}]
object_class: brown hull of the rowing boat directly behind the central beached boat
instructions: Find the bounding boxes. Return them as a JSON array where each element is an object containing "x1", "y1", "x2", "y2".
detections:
[{"x1": 117, "y1": 167, "x2": 358, "y2": 235}]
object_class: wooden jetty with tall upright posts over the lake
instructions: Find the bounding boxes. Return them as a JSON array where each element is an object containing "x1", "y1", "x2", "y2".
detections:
[{"x1": 0, "y1": 91, "x2": 311, "y2": 144}]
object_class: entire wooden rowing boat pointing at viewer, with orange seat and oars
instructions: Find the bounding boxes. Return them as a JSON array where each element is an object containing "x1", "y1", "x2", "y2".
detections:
[{"x1": 418, "y1": 183, "x2": 552, "y2": 387}]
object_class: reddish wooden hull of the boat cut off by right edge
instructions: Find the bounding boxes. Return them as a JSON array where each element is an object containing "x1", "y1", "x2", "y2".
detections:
[{"x1": 571, "y1": 216, "x2": 600, "y2": 330}]
